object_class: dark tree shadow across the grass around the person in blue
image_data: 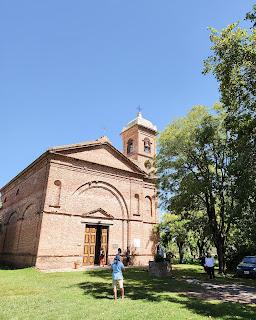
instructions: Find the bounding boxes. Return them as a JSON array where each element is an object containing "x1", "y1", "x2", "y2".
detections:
[{"x1": 78, "y1": 270, "x2": 256, "y2": 320}]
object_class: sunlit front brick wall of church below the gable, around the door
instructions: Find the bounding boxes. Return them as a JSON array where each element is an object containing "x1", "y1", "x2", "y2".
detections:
[{"x1": 36, "y1": 153, "x2": 157, "y2": 268}]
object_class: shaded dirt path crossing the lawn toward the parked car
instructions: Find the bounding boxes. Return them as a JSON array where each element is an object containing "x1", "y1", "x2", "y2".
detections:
[{"x1": 186, "y1": 279, "x2": 256, "y2": 304}]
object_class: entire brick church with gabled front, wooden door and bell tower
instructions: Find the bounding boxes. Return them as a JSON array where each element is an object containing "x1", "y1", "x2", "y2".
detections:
[{"x1": 0, "y1": 113, "x2": 158, "y2": 269}]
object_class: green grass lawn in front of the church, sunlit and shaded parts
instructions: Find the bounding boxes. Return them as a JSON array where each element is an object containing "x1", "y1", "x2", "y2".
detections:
[{"x1": 0, "y1": 265, "x2": 256, "y2": 320}]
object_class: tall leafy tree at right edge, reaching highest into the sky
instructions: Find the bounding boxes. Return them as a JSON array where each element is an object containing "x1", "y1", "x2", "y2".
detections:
[{"x1": 204, "y1": 5, "x2": 256, "y2": 223}]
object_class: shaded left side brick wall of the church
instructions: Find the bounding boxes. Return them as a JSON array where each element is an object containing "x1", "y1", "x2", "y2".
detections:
[{"x1": 0, "y1": 160, "x2": 47, "y2": 266}]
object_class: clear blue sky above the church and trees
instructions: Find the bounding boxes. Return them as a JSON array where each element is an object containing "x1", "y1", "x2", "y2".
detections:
[{"x1": 0, "y1": 0, "x2": 255, "y2": 186}]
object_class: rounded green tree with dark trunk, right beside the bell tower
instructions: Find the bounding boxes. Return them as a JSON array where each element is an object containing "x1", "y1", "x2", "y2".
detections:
[{"x1": 157, "y1": 105, "x2": 236, "y2": 272}]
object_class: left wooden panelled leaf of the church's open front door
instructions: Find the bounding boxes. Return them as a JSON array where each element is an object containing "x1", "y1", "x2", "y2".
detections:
[{"x1": 83, "y1": 226, "x2": 97, "y2": 266}]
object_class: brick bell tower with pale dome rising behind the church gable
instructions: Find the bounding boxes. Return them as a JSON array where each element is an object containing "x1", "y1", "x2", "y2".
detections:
[{"x1": 121, "y1": 112, "x2": 157, "y2": 173}]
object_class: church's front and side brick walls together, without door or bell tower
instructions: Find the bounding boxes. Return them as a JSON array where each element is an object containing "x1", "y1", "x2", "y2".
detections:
[{"x1": 0, "y1": 142, "x2": 158, "y2": 269}]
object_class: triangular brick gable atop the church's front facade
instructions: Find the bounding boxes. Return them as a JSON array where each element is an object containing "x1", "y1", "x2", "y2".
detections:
[{"x1": 54, "y1": 144, "x2": 144, "y2": 173}]
